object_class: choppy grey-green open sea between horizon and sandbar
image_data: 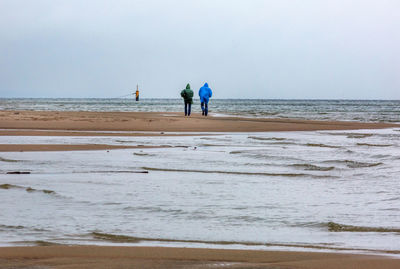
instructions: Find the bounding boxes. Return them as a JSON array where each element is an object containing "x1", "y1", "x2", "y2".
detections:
[{"x1": 0, "y1": 98, "x2": 400, "y2": 123}]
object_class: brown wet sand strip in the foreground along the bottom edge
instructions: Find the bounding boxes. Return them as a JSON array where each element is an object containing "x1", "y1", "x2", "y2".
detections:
[{"x1": 0, "y1": 246, "x2": 400, "y2": 269}]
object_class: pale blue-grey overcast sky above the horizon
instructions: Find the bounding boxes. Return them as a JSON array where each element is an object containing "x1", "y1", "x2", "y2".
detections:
[{"x1": 0, "y1": 0, "x2": 400, "y2": 99}]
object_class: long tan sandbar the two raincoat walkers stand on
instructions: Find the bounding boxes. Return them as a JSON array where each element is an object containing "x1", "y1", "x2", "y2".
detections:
[{"x1": 0, "y1": 111, "x2": 399, "y2": 135}]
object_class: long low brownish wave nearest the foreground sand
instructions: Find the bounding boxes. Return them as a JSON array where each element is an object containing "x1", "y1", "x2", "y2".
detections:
[{"x1": 90, "y1": 232, "x2": 400, "y2": 254}]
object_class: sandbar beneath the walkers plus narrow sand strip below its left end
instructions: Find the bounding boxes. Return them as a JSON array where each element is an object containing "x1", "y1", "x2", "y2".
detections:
[{"x1": 0, "y1": 111, "x2": 399, "y2": 151}]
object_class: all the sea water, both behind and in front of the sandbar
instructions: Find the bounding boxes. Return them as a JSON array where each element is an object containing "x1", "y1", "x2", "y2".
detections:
[{"x1": 0, "y1": 99, "x2": 400, "y2": 253}]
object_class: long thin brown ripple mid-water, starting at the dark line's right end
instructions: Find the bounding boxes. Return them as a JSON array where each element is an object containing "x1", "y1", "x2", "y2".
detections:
[{"x1": 142, "y1": 167, "x2": 332, "y2": 178}]
